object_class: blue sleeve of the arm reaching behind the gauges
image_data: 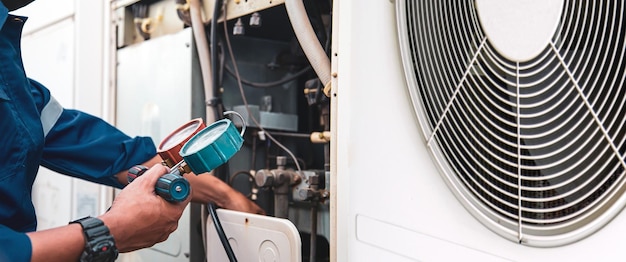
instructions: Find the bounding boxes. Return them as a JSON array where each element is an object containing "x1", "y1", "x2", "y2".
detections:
[{"x1": 30, "y1": 79, "x2": 156, "y2": 188}]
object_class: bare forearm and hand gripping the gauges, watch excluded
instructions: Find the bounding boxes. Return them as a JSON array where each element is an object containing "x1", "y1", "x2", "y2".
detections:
[{"x1": 27, "y1": 164, "x2": 193, "y2": 261}]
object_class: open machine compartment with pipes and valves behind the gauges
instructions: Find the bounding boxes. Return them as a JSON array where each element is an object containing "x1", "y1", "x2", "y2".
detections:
[{"x1": 111, "y1": 0, "x2": 330, "y2": 261}]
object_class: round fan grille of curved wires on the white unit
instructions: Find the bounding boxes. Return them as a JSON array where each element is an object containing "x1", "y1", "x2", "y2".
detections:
[{"x1": 397, "y1": 0, "x2": 626, "y2": 246}]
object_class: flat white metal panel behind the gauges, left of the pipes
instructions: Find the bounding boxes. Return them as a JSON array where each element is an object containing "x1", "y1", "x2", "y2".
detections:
[{"x1": 116, "y1": 29, "x2": 197, "y2": 261}]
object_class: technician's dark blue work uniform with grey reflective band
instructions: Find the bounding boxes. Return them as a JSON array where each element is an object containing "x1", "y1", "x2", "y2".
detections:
[{"x1": 0, "y1": 2, "x2": 156, "y2": 261}]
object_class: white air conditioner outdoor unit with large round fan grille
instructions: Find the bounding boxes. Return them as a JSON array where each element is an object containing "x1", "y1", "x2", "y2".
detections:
[{"x1": 331, "y1": 0, "x2": 626, "y2": 261}]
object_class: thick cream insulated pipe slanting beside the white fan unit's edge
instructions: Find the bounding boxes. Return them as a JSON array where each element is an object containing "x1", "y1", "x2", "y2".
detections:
[{"x1": 285, "y1": 0, "x2": 330, "y2": 87}]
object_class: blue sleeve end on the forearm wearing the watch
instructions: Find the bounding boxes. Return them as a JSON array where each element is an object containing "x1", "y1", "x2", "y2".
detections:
[{"x1": 0, "y1": 225, "x2": 32, "y2": 262}]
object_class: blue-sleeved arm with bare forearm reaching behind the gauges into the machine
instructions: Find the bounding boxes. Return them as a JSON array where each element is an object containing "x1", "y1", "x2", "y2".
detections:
[{"x1": 30, "y1": 77, "x2": 264, "y2": 214}]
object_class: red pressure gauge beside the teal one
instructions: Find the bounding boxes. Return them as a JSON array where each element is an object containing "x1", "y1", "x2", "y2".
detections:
[{"x1": 157, "y1": 118, "x2": 206, "y2": 172}]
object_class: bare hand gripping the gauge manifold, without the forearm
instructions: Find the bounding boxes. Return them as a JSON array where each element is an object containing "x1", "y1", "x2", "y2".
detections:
[{"x1": 100, "y1": 164, "x2": 191, "y2": 252}]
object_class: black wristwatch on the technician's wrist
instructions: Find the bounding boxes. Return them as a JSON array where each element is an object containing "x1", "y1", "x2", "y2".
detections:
[{"x1": 70, "y1": 217, "x2": 118, "y2": 262}]
